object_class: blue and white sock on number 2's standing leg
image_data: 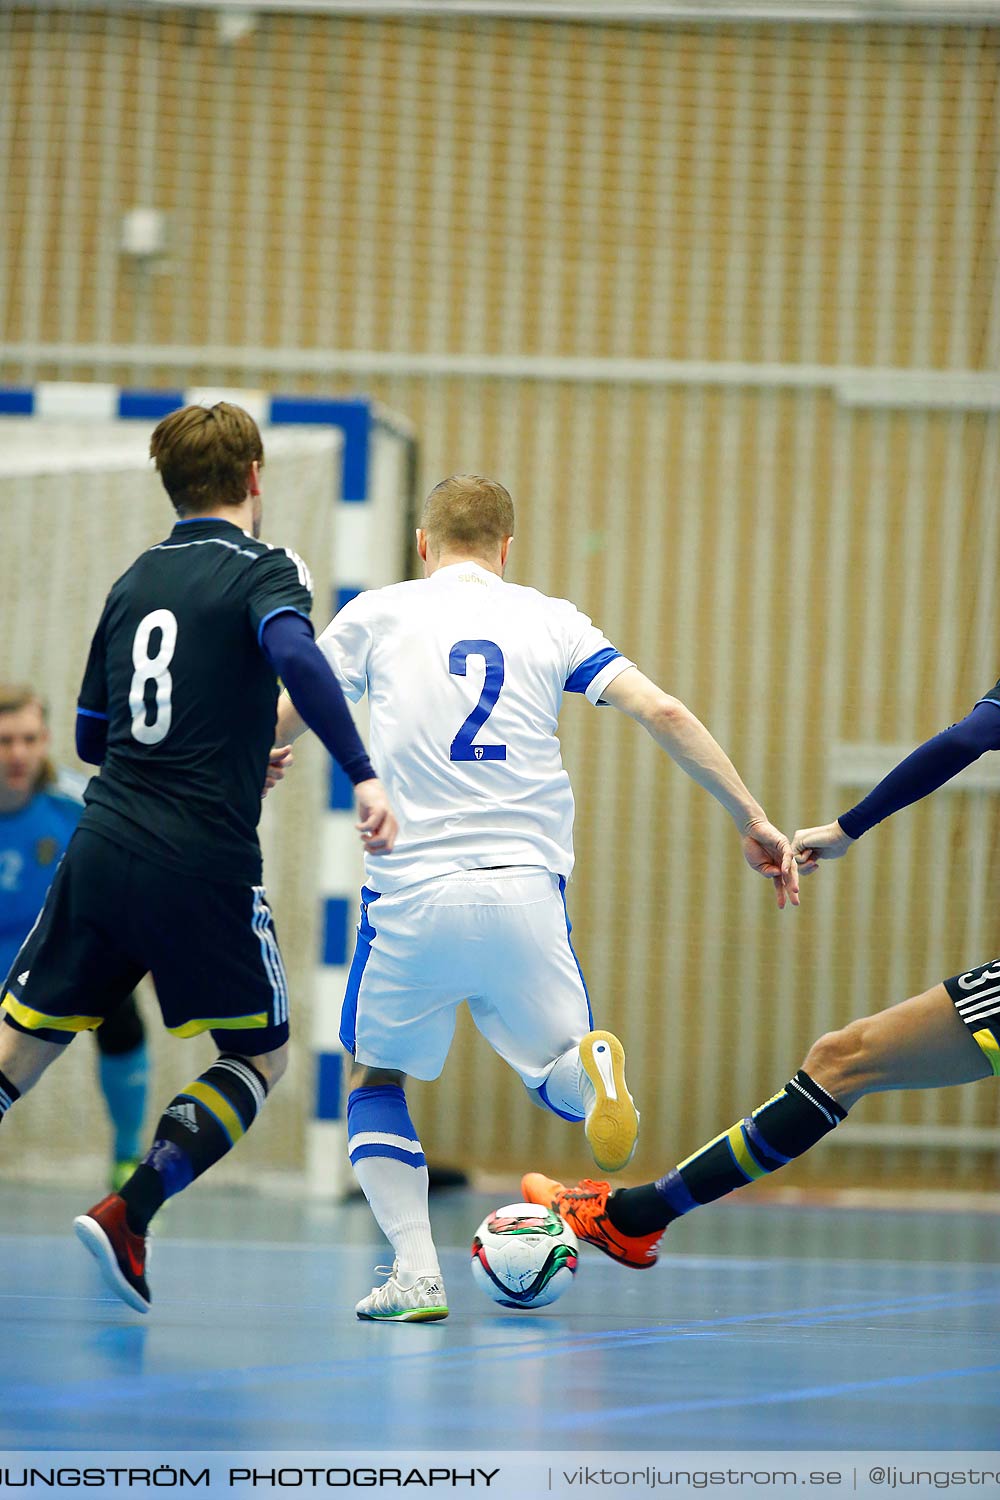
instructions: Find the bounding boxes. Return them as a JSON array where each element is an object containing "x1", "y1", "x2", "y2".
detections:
[{"x1": 348, "y1": 1085, "x2": 441, "y2": 1286}]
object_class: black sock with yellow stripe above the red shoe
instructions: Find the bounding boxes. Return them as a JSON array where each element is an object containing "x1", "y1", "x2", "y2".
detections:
[{"x1": 121, "y1": 1053, "x2": 267, "y2": 1235}]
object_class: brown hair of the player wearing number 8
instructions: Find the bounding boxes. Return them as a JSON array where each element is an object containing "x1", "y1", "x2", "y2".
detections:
[{"x1": 150, "y1": 401, "x2": 264, "y2": 516}]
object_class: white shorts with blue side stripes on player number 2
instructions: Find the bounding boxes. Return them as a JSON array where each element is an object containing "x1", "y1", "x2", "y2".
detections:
[{"x1": 340, "y1": 866, "x2": 594, "y2": 1089}]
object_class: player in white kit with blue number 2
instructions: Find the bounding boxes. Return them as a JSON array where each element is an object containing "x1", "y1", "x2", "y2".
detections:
[{"x1": 277, "y1": 474, "x2": 798, "y2": 1322}]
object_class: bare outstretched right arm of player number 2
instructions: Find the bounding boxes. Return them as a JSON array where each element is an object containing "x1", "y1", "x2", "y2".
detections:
[{"x1": 601, "y1": 668, "x2": 799, "y2": 908}]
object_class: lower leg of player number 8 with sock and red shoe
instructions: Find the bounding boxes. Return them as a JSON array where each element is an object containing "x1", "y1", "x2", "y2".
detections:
[{"x1": 73, "y1": 1043, "x2": 288, "y2": 1313}]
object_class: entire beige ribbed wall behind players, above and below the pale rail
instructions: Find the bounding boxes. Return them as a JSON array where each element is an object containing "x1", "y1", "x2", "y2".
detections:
[{"x1": 0, "y1": 8, "x2": 1000, "y2": 1188}]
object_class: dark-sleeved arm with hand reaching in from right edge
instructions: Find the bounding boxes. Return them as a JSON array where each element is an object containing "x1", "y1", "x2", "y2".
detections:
[{"x1": 792, "y1": 702, "x2": 1000, "y2": 875}]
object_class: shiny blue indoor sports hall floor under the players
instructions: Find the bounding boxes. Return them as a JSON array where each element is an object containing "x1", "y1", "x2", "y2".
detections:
[{"x1": 0, "y1": 1184, "x2": 1000, "y2": 1451}]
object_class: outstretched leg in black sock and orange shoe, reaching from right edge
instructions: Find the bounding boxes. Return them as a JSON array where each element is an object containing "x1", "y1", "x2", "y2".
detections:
[{"x1": 522, "y1": 971, "x2": 1000, "y2": 1269}]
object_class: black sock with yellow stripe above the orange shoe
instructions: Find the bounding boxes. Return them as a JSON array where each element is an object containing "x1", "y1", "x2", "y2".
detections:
[{"x1": 607, "y1": 1071, "x2": 847, "y2": 1235}]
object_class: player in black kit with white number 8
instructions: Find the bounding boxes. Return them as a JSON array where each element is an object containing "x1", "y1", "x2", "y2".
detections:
[{"x1": 0, "y1": 402, "x2": 396, "y2": 1313}]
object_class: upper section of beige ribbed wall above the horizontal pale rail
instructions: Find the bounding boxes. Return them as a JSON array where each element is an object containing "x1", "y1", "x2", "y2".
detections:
[{"x1": 0, "y1": 5, "x2": 1000, "y2": 368}]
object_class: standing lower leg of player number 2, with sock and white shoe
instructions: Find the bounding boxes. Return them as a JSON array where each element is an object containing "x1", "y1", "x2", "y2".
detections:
[{"x1": 348, "y1": 1062, "x2": 448, "y2": 1323}]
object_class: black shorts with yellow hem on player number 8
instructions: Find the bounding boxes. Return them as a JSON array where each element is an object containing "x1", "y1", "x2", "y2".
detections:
[{"x1": 3, "y1": 828, "x2": 288, "y2": 1056}]
